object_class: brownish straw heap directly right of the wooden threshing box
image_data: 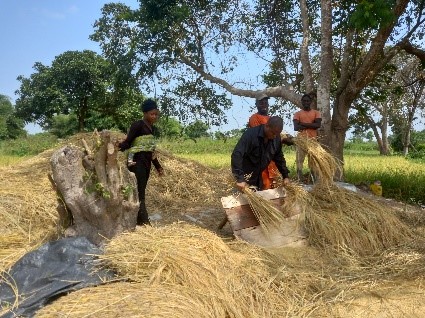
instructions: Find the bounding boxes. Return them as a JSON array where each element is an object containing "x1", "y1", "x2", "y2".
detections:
[{"x1": 306, "y1": 185, "x2": 414, "y2": 255}]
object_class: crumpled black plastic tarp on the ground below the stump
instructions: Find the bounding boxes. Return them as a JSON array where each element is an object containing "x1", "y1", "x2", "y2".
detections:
[{"x1": 0, "y1": 237, "x2": 113, "y2": 318}]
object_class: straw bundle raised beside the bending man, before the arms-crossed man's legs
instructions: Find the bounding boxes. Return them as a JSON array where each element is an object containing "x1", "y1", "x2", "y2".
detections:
[{"x1": 294, "y1": 135, "x2": 342, "y2": 184}]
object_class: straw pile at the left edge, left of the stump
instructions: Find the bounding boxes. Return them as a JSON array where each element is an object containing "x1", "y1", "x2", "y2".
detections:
[{"x1": 0, "y1": 150, "x2": 58, "y2": 272}]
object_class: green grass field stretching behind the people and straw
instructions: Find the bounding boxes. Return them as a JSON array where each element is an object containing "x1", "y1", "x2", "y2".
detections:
[{"x1": 0, "y1": 134, "x2": 425, "y2": 205}]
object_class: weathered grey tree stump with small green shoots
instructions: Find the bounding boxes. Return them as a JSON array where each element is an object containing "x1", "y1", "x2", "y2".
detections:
[{"x1": 50, "y1": 131, "x2": 139, "y2": 244}]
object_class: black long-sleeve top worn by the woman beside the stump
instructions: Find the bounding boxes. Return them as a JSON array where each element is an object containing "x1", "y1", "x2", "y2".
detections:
[{"x1": 119, "y1": 119, "x2": 161, "y2": 170}]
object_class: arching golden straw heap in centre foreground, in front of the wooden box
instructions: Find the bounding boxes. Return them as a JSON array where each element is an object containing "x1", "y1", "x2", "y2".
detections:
[{"x1": 100, "y1": 223, "x2": 284, "y2": 318}]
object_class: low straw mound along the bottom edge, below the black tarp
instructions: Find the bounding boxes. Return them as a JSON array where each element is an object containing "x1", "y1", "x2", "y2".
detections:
[{"x1": 37, "y1": 282, "x2": 226, "y2": 318}]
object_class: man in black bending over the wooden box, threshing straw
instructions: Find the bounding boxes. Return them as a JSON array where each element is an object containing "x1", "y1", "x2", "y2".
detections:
[{"x1": 231, "y1": 116, "x2": 289, "y2": 190}]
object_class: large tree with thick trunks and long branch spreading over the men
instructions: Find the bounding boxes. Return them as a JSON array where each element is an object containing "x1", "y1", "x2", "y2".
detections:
[{"x1": 92, "y1": 0, "x2": 424, "y2": 174}]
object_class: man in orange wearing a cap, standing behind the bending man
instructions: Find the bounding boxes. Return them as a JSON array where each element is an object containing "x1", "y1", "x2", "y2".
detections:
[{"x1": 248, "y1": 93, "x2": 278, "y2": 190}]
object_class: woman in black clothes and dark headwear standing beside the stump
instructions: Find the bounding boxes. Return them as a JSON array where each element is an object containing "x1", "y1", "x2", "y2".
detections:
[{"x1": 118, "y1": 99, "x2": 163, "y2": 225}]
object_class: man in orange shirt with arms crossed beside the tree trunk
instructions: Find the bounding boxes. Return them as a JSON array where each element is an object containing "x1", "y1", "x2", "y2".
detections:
[{"x1": 293, "y1": 94, "x2": 322, "y2": 180}]
